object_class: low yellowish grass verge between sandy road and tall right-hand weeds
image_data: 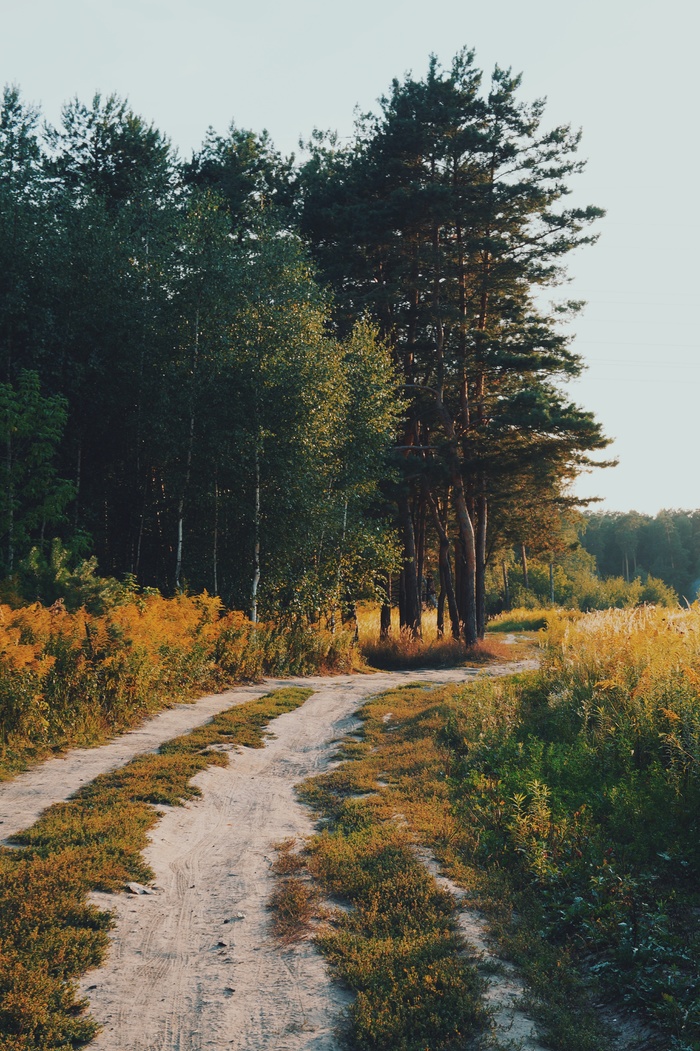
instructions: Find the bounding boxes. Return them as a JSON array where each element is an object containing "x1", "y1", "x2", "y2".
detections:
[{"x1": 301, "y1": 686, "x2": 486, "y2": 1051}]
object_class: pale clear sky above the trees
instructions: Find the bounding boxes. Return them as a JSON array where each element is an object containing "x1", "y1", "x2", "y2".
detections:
[{"x1": 0, "y1": 0, "x2": 700, "y2": 514}]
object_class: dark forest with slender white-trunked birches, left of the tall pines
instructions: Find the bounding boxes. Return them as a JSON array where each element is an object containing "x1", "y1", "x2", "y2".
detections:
[{"x1": 0, "y1": 89, "x2": 395, "y2": 617}]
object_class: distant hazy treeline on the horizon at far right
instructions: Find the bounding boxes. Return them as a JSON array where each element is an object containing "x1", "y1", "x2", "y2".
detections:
[{"x1": 580, "y1": 510, "x2": 700, "y2": 601}]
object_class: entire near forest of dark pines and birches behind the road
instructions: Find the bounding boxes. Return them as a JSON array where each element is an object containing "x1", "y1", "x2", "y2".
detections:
[{"x1": 0, "y1": 51, "x2": 606, "y2": 630}]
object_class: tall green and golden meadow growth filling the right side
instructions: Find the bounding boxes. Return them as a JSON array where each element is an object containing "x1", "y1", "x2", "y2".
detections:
[{"x1": 441, "y1": 606, "x2": 700, "y2": 1051}]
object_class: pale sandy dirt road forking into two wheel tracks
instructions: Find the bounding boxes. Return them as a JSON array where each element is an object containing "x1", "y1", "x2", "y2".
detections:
[{"x1": 0, "y1": 664, "x2": 533, "y2": 1051}]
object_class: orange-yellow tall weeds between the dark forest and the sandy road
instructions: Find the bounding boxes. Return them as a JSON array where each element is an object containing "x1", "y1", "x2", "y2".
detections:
[{"x1": 0, "y1": 593, "x2": 357, "y2": 779}]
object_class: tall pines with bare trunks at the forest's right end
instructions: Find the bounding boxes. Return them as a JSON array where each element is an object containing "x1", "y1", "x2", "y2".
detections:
[{"x1": 300, "y1": 48, "x2": 608, "y2": 643}]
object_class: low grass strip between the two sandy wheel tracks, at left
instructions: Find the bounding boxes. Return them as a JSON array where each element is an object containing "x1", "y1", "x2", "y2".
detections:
[{"x1": 0, "y1": 687, "x2": 312, "y2": 1051}]
